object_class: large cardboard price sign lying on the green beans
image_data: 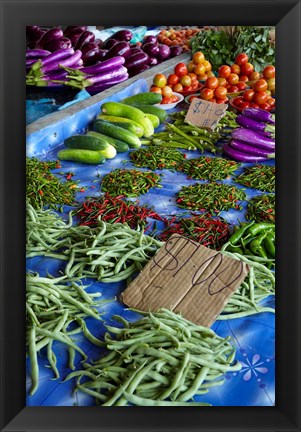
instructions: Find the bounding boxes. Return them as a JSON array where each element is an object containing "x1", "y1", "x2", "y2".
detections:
[{"x1": 121, "y1": 234, "x2": 249, "y2": 327}]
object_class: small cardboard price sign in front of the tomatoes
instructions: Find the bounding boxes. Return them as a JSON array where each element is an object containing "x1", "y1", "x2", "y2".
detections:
[{"x1": 185, "y1": 98, "x2": 228, "y2": 130}]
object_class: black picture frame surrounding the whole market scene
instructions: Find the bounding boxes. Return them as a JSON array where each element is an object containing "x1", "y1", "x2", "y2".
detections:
[{"x1": 0, "y1": 0, "x2": 301, "y2": 432}]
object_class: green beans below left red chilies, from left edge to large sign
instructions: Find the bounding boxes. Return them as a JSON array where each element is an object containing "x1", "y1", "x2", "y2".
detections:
[{"x1": 26, "y1": 203, "x2": 164, "y2": 283}]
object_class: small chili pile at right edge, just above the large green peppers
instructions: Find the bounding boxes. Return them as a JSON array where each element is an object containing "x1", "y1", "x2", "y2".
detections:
[{"x1": 246, "y1": 194, "x2": 275, "y2": 222}]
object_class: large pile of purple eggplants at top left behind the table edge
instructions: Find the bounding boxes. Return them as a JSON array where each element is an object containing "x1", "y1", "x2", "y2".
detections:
[{"x1": 26, "y1": 26, "x2": 182, "y2": 93}]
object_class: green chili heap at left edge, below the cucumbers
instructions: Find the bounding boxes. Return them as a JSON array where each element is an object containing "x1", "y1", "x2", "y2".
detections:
[{"x1": 26, "y1": 157, "x2": 78, "y2": 208}]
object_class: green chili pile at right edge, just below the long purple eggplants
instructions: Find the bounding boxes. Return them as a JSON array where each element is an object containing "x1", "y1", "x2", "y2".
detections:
[{"x1": 235, "y1": 165, "x2": 275, "y2": 192}]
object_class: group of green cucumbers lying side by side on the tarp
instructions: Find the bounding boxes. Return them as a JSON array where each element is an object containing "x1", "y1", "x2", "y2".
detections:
[{"x1": 57, "y1": 92, "x2": 167, "y2": 164}]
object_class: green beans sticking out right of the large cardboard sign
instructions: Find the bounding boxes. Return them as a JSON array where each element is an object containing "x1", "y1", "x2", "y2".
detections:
[{"x1": 217, "y1": 245, "x2": 275, "y2": 320}]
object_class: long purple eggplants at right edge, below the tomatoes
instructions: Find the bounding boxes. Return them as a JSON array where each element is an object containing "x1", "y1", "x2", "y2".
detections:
[{"x1": 223, "y1": 108, "x2": 275, "y2": 162}]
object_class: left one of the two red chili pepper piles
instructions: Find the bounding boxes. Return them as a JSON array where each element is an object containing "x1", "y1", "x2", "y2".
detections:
[{"x1": 76, "y1": 193, "x2": 164, "y2": 229}]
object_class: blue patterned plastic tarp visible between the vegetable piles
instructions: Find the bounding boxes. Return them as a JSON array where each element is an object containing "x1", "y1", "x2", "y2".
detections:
[{"x1": 26, "y1": 79, "x2": 275, "y2": 406}]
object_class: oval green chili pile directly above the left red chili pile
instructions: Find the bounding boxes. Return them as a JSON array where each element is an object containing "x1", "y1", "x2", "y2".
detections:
[{"x1": 101, "y1": 169, "x2": 162, "y2": 197}]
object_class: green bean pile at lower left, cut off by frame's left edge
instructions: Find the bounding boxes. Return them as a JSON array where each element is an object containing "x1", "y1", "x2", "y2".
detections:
[{"x1": 26, "y1": 273, "x2": 111, "y2": 395}]
